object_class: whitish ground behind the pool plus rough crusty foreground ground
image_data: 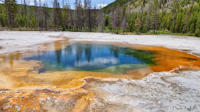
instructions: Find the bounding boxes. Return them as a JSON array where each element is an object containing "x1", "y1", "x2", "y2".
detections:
[{"x1": 0, "y1": 32, "x2": 200, "y2": 112}]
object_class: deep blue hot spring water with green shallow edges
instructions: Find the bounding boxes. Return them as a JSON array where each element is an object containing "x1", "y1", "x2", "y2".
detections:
[{"x1": 25, "y1": 43, "x2": 155, "y2": 74}]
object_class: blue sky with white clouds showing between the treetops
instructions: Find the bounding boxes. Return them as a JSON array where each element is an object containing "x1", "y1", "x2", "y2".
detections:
[{"x1": 13, "y1": 0, "x2": 115, "y2": 8}]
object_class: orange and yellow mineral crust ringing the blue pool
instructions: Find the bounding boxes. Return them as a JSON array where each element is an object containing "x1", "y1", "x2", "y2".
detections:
[{"x1": 0, "y1": 41, "x2": 200, "y2": 112}]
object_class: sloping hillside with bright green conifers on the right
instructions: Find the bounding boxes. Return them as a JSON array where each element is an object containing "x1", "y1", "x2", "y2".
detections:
[{"x1": 103, "y1": 0, "x2": 200, "y2": 36}]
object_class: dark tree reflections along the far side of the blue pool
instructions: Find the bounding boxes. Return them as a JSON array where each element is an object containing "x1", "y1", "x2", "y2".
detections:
[{"x1": 51, "y1": 44, "x2": 154, "y2": 68}]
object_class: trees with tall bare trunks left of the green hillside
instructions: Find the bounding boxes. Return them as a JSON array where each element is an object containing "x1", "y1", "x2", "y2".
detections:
[{"x1": 0, "y1": 0, "x2": 103, "y2": 31}]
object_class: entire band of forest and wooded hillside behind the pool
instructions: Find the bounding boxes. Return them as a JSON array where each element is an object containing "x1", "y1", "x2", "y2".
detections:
[{"x1": 0, "y1": 0, "x2": 200, "y2": 36}]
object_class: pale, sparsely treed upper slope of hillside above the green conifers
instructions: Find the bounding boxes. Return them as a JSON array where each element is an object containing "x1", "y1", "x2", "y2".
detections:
[{"x1": 103, "y1": 0, "x2": 199, "y2": 13}]
